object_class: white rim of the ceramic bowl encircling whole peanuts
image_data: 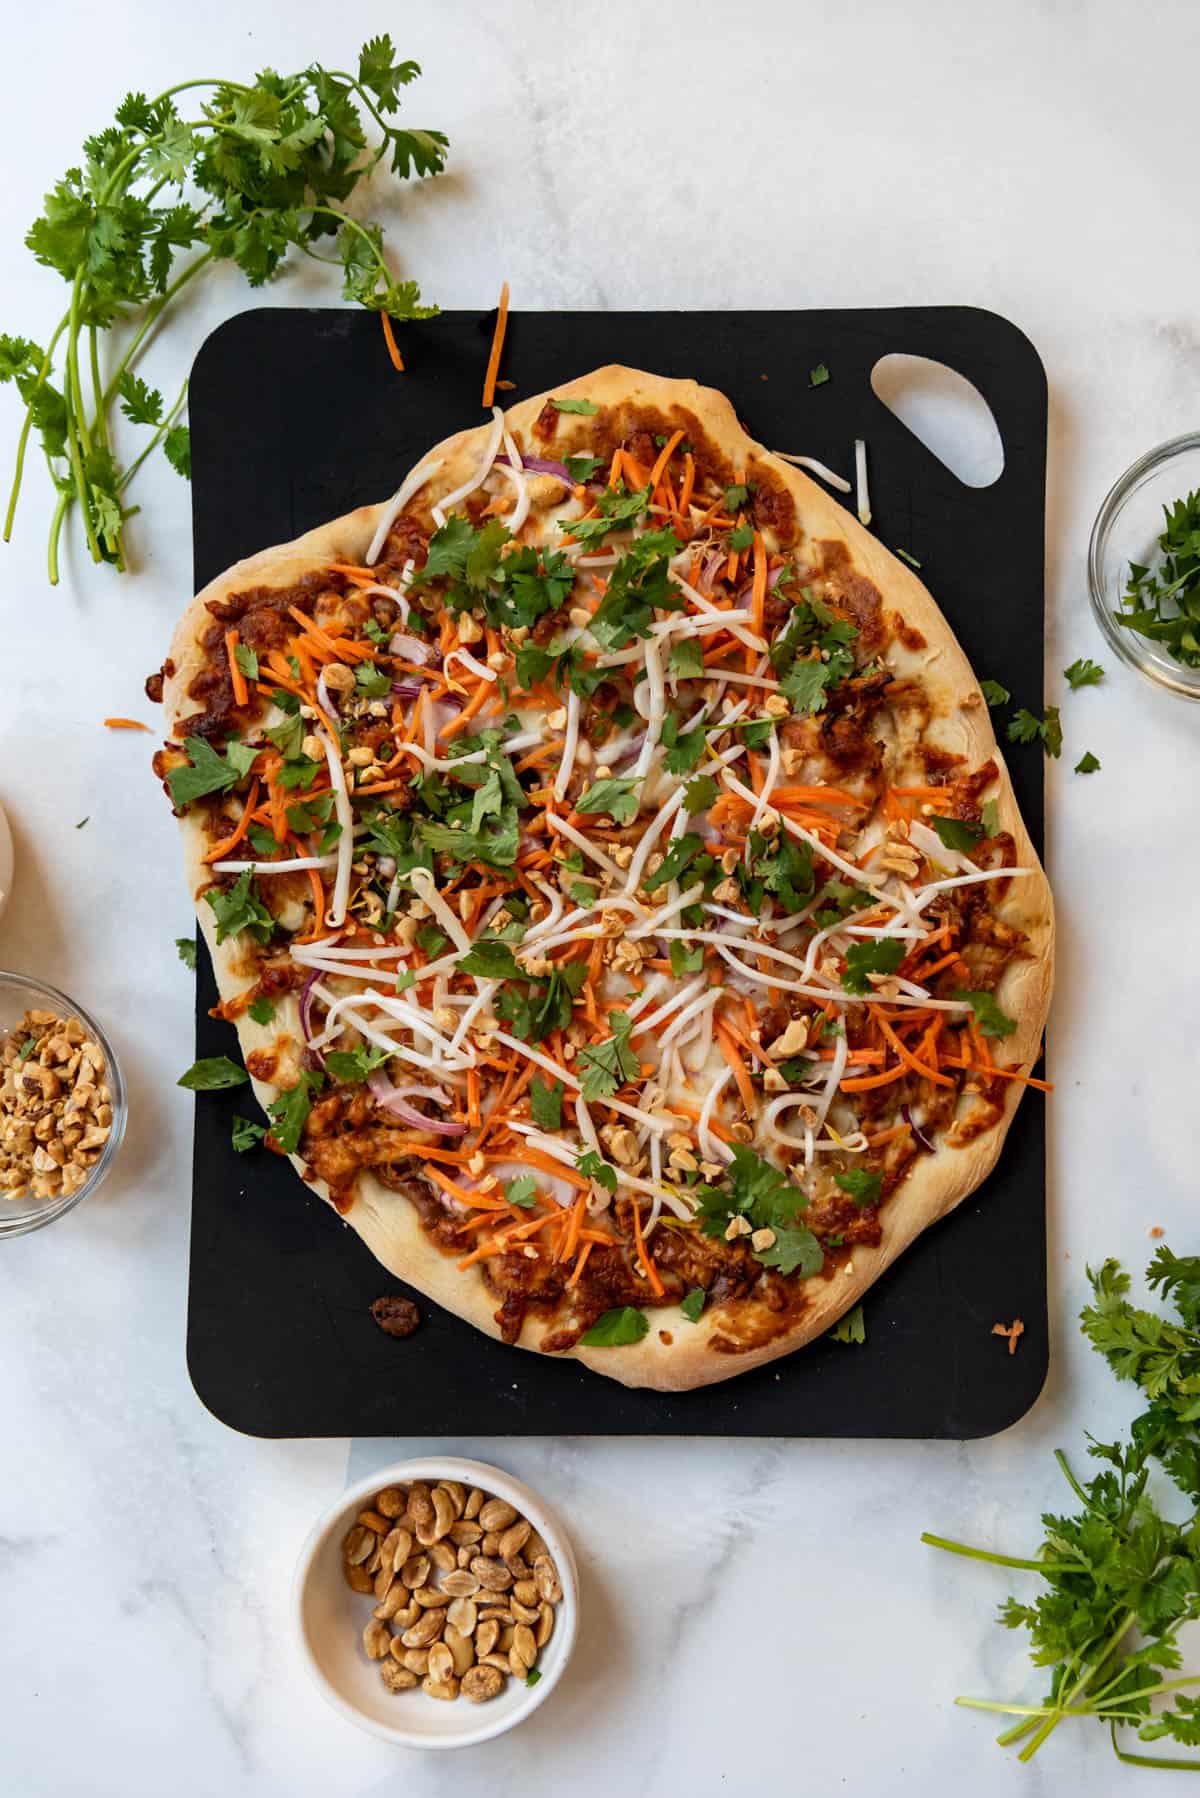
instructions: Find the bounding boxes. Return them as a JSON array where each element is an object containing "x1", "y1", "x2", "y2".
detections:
[{"x1": 291, "y1": 1455, "x2": 579, "y2": 1749}]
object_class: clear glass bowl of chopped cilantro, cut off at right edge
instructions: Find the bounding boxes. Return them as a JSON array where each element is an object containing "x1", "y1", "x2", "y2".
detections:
[{"x1": 1088, "y1": 432, "x2": 1200, "y2": 699}]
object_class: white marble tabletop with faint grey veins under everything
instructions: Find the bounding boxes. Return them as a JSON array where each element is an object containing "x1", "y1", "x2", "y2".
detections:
[{"x1": 0, "y1": 0, "x2": 1200, "y2": 1798}]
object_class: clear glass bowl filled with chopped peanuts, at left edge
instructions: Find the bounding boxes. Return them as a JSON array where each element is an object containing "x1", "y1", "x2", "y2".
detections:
[{"x1": 0, "y1": 969, "x2": 126, "y2": 1237}]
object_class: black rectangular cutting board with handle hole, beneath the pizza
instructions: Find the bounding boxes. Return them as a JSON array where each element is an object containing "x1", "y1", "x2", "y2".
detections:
[{"x1": 187, "y1": 306, "x2": 1047, "y2": 1438}]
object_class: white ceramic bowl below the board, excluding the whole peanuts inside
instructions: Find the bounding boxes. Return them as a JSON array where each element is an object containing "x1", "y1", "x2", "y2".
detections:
[{"x1": 291, "y1": 1456, "x2": 579, "y2": 1748}]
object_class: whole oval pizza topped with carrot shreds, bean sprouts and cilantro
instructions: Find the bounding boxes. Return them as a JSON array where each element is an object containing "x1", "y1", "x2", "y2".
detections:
[{"x1": 151, "y1": 367, "x2": 1054, "y2": 1390}]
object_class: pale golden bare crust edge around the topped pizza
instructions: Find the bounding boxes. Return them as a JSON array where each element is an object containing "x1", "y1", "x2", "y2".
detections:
[{"x1": 164, "y1": 365, "x2": 1054, "y2": 1392}]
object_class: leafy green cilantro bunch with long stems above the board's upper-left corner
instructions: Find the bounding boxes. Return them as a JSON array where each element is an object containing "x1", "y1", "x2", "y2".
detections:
[{"x1": 0, "y1": 36, "x2": 446, "y2": 584}]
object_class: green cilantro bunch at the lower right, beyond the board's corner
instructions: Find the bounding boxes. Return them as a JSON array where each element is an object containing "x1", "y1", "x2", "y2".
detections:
[{"x1": 921, "y1": 1246, "x2": 1200, "y2": 1771}]
